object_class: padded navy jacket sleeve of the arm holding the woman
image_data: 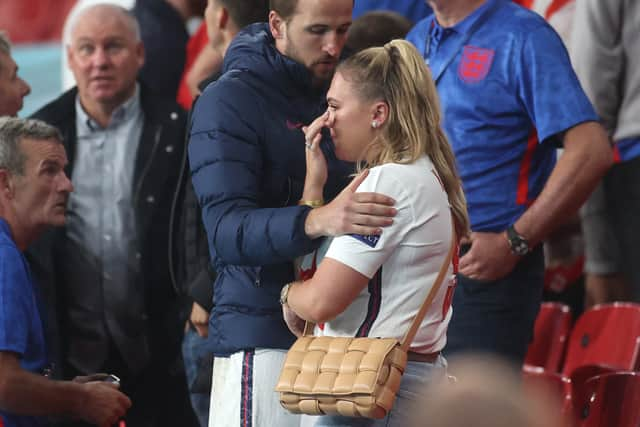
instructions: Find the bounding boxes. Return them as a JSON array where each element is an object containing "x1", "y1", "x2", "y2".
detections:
[{"x1": 189, "y1": 95, "x2": 319, "y2": 266}]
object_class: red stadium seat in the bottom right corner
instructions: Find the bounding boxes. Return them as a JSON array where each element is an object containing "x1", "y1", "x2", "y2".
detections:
[{"x1": 578, "y1": 372, "x2": 640, "y2": 427}]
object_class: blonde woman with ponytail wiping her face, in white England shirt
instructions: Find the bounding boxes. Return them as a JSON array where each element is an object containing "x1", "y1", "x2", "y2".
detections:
[{"x1": 281, "y1": 40, "x2": 469, "y2": 426}]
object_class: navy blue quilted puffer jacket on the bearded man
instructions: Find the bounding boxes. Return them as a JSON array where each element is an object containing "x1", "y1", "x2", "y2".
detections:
[{"x1": 189, "y1": 24, "x2": 353, "y2": 356}]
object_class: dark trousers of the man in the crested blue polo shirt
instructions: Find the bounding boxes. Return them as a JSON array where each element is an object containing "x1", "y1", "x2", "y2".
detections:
[{"x1": 444, "y1": 245, "x2": 544, "y2": 365}]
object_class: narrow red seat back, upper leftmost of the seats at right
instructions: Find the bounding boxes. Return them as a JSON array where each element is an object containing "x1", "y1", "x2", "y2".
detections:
[{"x1": 524, "y1": 302, "x2": 571, "y2": 372}]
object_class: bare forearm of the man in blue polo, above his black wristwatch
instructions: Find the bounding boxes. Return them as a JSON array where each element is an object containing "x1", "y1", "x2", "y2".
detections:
[{"x1": 514, "y1": 122, "x2": 613, "y2": 245}]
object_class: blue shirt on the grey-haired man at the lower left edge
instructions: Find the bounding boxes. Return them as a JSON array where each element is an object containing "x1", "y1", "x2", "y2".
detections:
[{"x1": 0, "y1": 218, "x2": 47, "y2": 427}]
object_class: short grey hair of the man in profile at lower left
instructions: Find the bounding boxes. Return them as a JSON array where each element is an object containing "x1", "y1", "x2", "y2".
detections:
[{"x1": 0, "y1": 117, "x2": 62, "y2": 175}]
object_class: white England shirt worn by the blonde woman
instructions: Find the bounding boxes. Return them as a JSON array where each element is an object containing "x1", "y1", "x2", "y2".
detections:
[{"x1": 316, "y1": 156, "x2": 455, "y2": 353}]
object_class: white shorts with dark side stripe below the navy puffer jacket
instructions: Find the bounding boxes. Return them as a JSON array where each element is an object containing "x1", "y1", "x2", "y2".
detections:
[{"x1": 209, "y1": 349, "x2": 300, "y2": 427}]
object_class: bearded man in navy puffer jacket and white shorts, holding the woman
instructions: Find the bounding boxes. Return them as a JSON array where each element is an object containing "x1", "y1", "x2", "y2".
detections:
[{"x1": 189, "y1": 0, "x2": 394, "y2": 427}]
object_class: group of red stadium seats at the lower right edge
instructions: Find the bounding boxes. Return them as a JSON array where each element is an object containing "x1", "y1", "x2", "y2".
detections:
[{"x1": 523, "y1": 303, "x2": 640, "y2": 427}]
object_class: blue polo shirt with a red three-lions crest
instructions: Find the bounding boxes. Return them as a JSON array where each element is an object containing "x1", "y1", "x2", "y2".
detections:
[{"x1": 407, "y1": 0, "x2": 597, "y2": 231}]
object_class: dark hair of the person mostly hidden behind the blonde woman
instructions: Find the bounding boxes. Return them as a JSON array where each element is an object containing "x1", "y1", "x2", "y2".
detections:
[{"x1": 345, "y1": 11, "x2": 413, "y2": 54}]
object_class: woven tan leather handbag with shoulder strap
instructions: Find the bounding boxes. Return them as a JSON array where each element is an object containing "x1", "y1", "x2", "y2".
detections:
[{"x1": 276, "y1": 226, "x2": 456, "y2": 418}]
